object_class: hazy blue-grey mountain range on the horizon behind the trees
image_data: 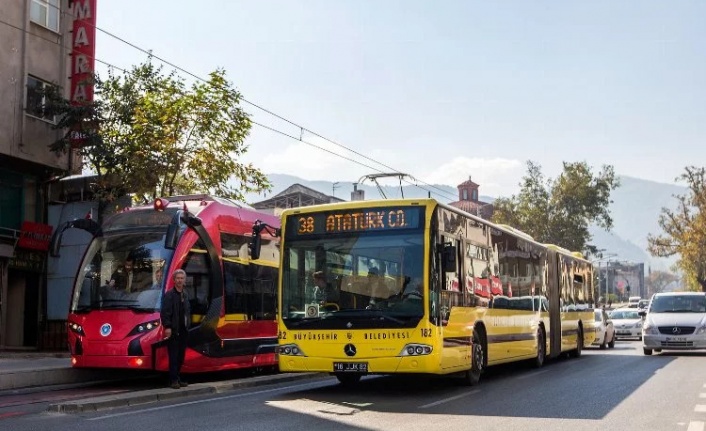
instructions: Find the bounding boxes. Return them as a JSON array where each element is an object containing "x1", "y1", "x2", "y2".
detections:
[{"x1": 245, "y1": 174, "x2": 688, "y2": 271}]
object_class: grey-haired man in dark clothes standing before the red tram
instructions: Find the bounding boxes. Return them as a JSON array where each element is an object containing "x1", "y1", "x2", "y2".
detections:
[{"x1": 161, "y1": 269, "x2": 191, "y2": 389}]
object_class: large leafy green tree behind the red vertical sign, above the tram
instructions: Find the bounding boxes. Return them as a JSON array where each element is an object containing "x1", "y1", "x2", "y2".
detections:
[{"x1": 44, "y1": 61, "x2": 271, "y2": 215}]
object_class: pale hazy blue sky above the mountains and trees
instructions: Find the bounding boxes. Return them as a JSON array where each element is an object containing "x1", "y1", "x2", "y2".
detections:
[{"x1": 96, "y1": 0, "x2": 706, "y2": 196}]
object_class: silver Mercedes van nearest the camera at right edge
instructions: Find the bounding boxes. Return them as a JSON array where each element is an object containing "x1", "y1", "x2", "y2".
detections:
[{"x1": 640, "y1": 292, "x2": 706, "y2": 355}]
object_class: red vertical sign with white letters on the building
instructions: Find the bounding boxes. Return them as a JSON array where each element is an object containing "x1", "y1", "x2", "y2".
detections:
[{"x1": 70, "y1": 0, "x2": 96, "y2": 143}]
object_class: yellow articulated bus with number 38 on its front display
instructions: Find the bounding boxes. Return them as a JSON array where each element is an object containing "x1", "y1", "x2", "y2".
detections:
[{"x1": 253, "y1": 199, "x2": 595, "y2": 384}]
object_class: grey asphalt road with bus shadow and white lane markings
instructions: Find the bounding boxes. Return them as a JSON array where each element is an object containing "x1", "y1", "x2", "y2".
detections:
[{"x1": 0, "y1": 341, "x2": 706, "y2": 431}]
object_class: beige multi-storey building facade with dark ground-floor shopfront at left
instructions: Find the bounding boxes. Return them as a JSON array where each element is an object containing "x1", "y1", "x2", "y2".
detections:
[{"x1": 0, "y1": 0, "x2": 86, "y2": 350}]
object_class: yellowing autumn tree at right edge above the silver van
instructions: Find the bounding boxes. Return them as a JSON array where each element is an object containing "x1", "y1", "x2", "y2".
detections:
[{"x1": 647, "y1": 166, "x2": 706, "y2": 292}]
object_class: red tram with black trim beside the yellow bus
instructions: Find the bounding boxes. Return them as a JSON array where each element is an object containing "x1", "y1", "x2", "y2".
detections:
[{"x1": 52, "y1": 195, "x2": 280, "y2": 373}]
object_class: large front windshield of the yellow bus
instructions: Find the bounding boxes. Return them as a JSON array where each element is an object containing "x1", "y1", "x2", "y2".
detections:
[{"x1": 281, "y1": 228, "x2": 426, "y2": 329}]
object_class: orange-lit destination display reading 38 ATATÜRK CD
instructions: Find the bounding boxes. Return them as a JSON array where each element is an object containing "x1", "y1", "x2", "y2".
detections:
[{"x1": 287, "y1": 207, "x2": 423, "y2": 237}]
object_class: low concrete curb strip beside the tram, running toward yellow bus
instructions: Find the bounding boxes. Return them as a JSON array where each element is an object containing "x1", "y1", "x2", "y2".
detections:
[{"x1": 47, "y1": 373, "x2": 328, "y2": 414}]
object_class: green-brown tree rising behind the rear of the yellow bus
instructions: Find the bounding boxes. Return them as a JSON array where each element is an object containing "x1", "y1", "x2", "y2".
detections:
[{"x1": 492, "y1": 161, "x2": 620, "y2": 255}]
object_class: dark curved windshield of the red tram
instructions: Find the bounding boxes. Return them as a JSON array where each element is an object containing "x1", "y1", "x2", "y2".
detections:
[{"x1": 71, "y1": 229, "x2": 173, "y2": 313}]
